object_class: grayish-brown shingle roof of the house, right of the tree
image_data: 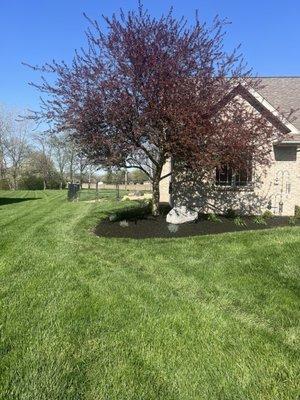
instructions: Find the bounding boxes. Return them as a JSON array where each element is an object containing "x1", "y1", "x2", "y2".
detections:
[{"x1": 258, "y1": 76, "x2": 300, "y2": 130}]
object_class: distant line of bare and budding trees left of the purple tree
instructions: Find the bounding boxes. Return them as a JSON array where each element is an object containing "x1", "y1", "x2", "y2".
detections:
[{"x1": 0, "y1": 106, "x2": 99, "y2": 190}]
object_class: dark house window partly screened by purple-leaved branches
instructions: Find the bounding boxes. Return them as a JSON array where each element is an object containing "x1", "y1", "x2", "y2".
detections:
[{"x1": 216, "y1": 165, "x2": 252, "y2": 187}]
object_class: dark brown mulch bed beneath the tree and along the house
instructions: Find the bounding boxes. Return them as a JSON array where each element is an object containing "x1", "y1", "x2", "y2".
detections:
[{"x1": 95, "y1": 216, "x2": 300, "y2": 239}]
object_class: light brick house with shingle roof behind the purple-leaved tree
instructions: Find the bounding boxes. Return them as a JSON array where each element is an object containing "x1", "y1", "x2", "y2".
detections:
[{"x1": 160, "y1": 77, "x2": 300, "y2": 216}]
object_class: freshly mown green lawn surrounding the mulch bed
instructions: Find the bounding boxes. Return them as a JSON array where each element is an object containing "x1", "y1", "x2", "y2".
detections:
[{"x1": 0, "y1": 191, "x2": 300, "y2": 400}]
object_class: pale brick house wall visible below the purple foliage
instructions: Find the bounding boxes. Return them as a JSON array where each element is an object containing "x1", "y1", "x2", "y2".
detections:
[{"x1": 160, "y1": 145, "x2": 300, "y2": 216}]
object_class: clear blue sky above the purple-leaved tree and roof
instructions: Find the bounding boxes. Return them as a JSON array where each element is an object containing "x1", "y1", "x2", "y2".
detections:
[{"x1": 0, "y1": 0, "x2": 300, "y2": 108}]
